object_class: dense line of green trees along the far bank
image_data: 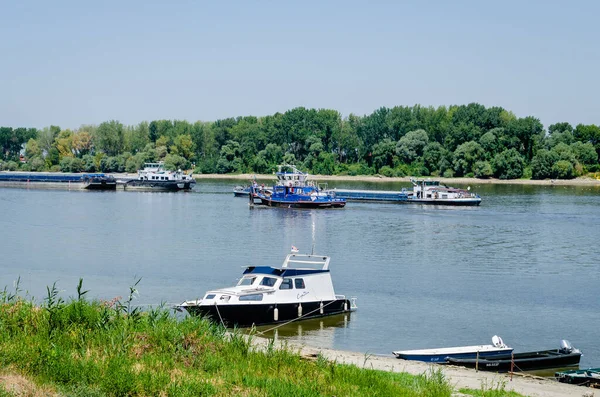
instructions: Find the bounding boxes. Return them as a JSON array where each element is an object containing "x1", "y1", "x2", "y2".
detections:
[{"x1": 0, "y1": 103, "x2": 600, "y2": 179}]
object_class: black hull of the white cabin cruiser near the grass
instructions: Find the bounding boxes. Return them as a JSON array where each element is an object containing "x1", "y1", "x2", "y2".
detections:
[{"x1": 183, "y1": 299, "x2": 351, "y2": 327}]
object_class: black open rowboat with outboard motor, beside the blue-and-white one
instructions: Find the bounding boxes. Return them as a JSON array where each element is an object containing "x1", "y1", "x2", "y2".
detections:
[{"x1": 446, "y1": 340, "x2": 581, "y2": 372}]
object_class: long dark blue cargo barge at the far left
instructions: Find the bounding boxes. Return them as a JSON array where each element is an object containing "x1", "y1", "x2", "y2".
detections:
[{"x1": 0, "y1": 171, "x2": 117, "y2": 190}]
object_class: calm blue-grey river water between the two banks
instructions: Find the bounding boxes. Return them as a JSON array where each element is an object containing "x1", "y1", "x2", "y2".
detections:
[{"x1": 0, "y1": 180, "x2": 600, "y2": 367}]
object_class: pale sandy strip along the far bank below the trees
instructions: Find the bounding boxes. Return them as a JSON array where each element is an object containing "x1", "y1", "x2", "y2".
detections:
[{"x1": 194, "y1": 174, "x2": 600, "y2": 186}]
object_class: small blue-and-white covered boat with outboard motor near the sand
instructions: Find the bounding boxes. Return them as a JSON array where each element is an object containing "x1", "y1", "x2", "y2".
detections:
[{"x1": 392, "y1": 335, "x2": 513, "y2": 363}]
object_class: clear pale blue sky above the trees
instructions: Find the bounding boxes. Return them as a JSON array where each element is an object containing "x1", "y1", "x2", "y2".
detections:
[{"x1": 0, "y1": 0, "x2": 600, "y2": 129}]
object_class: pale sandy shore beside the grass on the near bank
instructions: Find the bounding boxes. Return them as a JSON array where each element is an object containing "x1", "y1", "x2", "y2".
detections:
[{"x1": 253, "y1": 337, "x2": 594, "y2": 397}]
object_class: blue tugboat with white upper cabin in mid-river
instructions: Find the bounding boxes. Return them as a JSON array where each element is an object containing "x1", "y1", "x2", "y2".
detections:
[{"x1": 249, "y1": 164, "x2": 346, "y2": 208}]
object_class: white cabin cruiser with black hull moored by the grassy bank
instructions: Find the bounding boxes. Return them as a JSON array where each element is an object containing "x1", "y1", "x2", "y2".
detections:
[{"x1": 177, "y1": 253, "x2": 356, "y2": 327}]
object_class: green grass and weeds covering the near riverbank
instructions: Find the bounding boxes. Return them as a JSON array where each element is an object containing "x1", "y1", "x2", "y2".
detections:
[{"x1": 0, "y1": 280, "x2": 518, "y2": 396}]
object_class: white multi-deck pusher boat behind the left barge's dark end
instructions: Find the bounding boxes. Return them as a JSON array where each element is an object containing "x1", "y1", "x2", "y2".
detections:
[{"x1": 119, "y1": 161, "x2": 196, "y2": 192}]
